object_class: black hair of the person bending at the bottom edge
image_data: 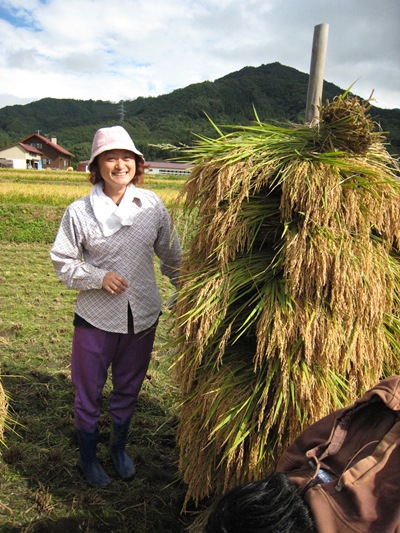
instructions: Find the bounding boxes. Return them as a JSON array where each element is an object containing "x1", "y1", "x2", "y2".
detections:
[{"x1": 205, "y1": 473, "x2": 316, "y2": 533}]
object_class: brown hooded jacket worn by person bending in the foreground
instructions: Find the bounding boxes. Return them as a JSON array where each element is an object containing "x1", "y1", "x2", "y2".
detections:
[{"x1": 277, "y1": 376, "x2": 400, "y2": 533}]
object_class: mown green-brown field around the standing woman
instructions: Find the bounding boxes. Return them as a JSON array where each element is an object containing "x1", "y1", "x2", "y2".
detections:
[{"x1": 0, "y1": 171, "x2": 200, "y2": 533}]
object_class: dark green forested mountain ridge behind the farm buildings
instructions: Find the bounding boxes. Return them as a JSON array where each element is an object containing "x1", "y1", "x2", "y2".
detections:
[{"x1": 0, "y1": 63, "x2": 400, "y2": 163}]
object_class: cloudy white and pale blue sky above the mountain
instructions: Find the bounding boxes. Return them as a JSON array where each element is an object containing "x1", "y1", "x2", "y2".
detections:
[{"x1": 0, "y1": 0, "x2": 400, "y2": 109}]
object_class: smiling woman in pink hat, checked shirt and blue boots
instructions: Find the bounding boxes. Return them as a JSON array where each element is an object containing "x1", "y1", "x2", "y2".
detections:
[{"x1": 50, "y1": 126, "x2": 182, "y2": 486}]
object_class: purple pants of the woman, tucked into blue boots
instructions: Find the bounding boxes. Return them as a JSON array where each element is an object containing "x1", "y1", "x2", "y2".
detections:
[{"x1": 71, "y1": 323, "x2": 157, "y2": 433}]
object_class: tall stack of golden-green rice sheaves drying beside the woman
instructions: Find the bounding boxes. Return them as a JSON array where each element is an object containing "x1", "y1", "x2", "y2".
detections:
[{"x1": 175, "y1": 95, "x2": 400, "y2": 505}]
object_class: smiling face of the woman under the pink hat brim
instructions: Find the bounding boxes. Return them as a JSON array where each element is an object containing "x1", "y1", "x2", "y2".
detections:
[{"x1": 98, "y1": 149, "x2": 136, "y2": 191}]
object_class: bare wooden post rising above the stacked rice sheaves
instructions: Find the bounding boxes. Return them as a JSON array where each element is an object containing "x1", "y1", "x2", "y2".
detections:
[{"x1": 306, "y1": 24, "x2": 329, "y2": 126}]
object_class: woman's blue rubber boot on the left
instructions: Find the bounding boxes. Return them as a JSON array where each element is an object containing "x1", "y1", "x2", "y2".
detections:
[{"x1": 76, "y1": 428, "x2": 111, "y2": 487}]
